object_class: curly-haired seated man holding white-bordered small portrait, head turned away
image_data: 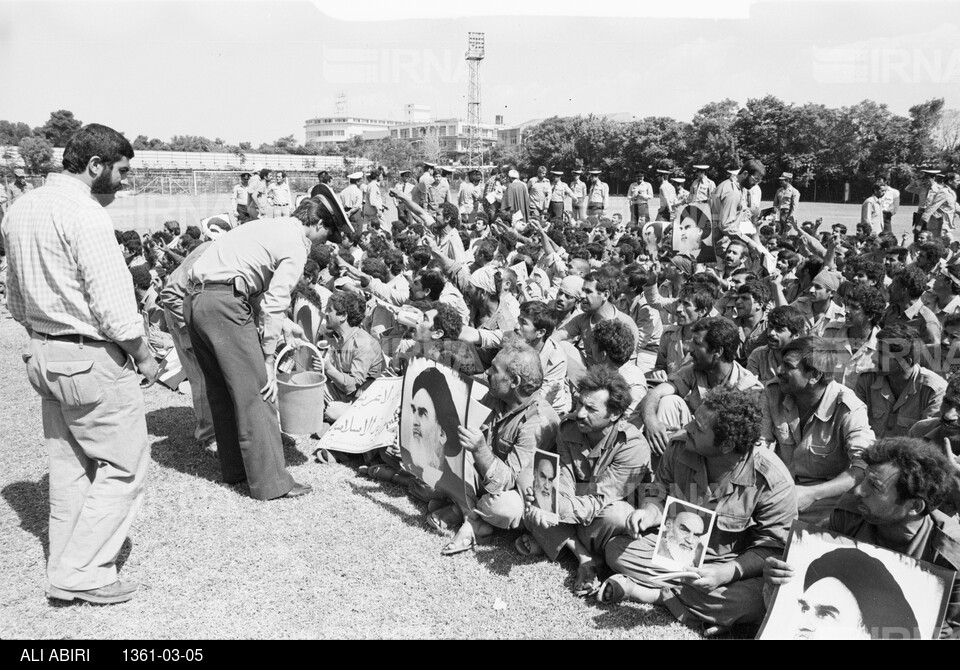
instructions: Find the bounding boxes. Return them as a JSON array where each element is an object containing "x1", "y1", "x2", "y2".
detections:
[{"x1": 597, "y1": 388, "x2": 797, "y2": 634}]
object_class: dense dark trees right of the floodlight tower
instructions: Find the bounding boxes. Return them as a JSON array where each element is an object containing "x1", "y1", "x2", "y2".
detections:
[{"x1": 519, "y1": 95, "x2": 960, "y2": 200}]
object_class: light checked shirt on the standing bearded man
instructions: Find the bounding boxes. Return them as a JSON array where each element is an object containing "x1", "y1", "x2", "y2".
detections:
[{"x1": 2, "y1": 174, "x2": 144, "y2": 341}]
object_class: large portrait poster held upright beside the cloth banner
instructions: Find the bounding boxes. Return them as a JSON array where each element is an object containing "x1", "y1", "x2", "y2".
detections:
[{"x1": 400, "y1": 358, "x2": 476, "y2": 509}]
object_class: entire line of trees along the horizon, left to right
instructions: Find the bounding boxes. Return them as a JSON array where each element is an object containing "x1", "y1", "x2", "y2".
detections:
[{"x1": 0, "y1": 95, "x2": 960, "y2": 200}]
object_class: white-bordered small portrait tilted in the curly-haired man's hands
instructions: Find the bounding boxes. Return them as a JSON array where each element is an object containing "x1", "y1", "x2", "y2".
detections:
[{"x1": 653, "y1": 497, "x2": 716, "y2": 570}]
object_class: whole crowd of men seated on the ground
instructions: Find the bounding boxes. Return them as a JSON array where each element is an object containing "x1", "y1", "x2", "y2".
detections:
[{"x1": 118, "y1": 163, "x2": 960, "y2": 636}]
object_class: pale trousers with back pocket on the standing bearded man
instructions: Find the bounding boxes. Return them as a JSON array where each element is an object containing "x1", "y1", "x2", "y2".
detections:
[{"x1": 24, "y1": 334, "x2": 150, "y2": 591}]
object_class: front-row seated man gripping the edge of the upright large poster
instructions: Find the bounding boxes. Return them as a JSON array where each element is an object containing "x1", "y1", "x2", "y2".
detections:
[{"x1": 441, "y1": 336, "x2": 560, "y2": 555}]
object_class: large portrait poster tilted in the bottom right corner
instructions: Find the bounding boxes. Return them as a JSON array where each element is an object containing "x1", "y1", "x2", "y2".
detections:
[{"x1": 757, "y1": 521, "x2": 955, "y2": 640}]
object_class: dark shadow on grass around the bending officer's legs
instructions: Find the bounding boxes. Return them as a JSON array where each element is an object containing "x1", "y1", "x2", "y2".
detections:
[{"x1": 147, "y1": 407, "x2": 309, "y2": 483}]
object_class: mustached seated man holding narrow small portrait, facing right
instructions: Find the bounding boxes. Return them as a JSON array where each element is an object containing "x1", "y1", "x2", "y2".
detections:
[{"x1": 515, "y1": 365, "x2": 650, "y2": 595}]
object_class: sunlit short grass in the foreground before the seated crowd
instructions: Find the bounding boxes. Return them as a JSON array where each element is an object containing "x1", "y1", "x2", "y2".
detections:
[{"x1": 0, "y1": 310, "x2": 698, "y2": 640}]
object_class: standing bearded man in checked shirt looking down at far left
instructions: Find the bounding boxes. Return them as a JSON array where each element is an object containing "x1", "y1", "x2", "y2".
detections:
[{"x1": 3, "y1": 124, "x2": 159, "y2": 604}]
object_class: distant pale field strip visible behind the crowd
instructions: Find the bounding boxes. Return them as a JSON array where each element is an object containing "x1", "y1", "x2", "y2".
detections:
[{"x1": 108, "y1": 194, "x2": 913, "y2": 240}]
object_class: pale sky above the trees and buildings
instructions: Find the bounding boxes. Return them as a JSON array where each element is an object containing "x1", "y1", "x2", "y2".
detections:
[{"x1": 0, "y1": 0, "x2": 960, "y2": 146}]
